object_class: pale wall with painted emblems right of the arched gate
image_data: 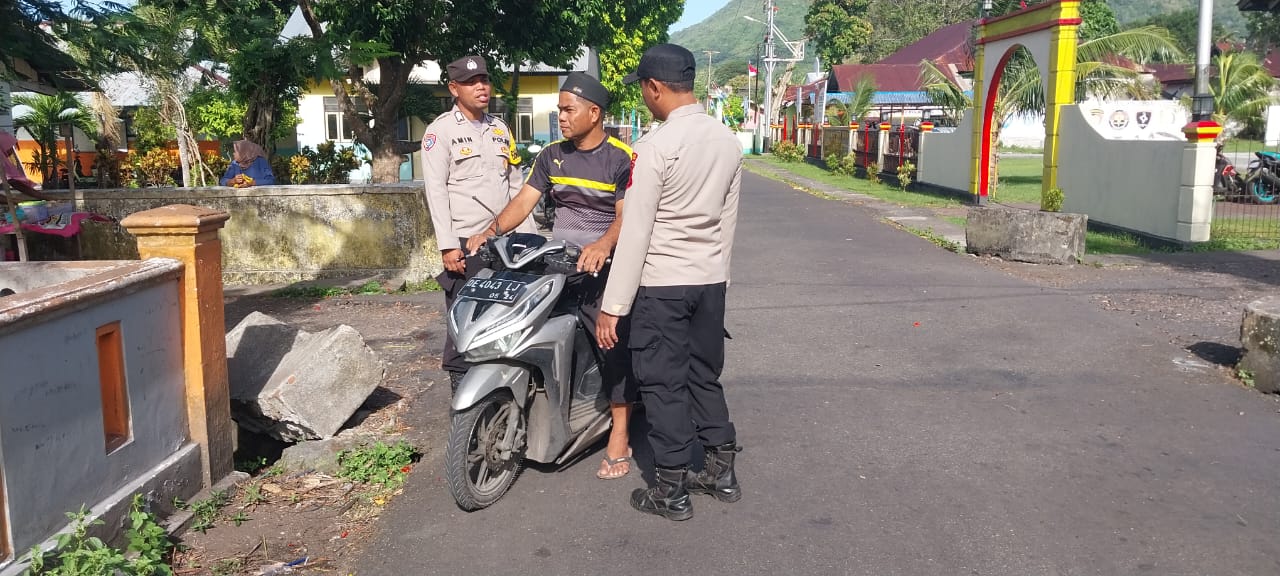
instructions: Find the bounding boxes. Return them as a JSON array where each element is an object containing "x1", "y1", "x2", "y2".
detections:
[{"x1": 1059, "y1": 106, "x2": 1187, "y2": 239}]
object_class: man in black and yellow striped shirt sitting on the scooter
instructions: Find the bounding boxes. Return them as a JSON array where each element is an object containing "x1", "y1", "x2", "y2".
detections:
[{"x1": 467, "y1": 72, "x2": 637, "y2": 480}]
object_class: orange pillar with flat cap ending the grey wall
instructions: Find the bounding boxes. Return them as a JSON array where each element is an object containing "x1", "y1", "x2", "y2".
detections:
[{"x1": 120, "y1": 205, "x2": 236, "y2": 486}]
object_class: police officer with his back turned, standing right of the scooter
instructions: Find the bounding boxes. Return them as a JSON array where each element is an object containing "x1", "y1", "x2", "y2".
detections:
[{"x1": 596, "y1": 44, "x2": 742, "y2": 520}]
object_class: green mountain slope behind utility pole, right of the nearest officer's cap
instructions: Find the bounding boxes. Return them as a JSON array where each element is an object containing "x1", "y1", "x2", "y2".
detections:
[{"x1": 671, "y1": 0, "x2": 812, "y2": 66}]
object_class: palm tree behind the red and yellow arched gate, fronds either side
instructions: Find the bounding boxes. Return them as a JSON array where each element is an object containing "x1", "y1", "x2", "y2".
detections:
[{"x1": 920, "y1": 26, "x2": 1183, "y2": 193}]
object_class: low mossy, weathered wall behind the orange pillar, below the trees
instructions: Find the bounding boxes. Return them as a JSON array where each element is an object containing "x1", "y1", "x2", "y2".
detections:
[{"x1": 70, "y1": 182, "x2": 440, "y2": 284}]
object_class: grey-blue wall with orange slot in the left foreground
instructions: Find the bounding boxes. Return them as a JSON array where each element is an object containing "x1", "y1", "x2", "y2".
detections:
[{"x1": 0, "y1": 260, "x2": 201, "y2": 565}]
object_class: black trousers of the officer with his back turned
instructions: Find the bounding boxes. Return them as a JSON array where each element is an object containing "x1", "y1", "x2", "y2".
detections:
[{"x1": 628, "y1": 283, "x2": 737, "y2": 468}]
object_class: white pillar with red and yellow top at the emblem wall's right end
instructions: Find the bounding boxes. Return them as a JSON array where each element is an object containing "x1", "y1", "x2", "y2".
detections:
[{"x1": 1174, "y1": 120, "x2": 1222, "y2": 242}]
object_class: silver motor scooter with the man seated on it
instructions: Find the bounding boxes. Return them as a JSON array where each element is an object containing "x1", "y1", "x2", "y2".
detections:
[{"x1": 444, "y1": 234, "x2": 612, "y2": 511}]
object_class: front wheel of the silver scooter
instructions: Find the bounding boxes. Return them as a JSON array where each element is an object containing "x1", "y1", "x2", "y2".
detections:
[{"x1": 444, "y1": 390, "x2": 526, "y2": 512}]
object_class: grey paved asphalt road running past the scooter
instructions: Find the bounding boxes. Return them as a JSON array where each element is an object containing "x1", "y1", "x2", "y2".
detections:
[{"x1": 358, "y1": 174, "x2": 1280, "y2": 576}]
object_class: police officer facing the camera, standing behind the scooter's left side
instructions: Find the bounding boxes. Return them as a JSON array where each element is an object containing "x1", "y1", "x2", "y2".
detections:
[{"x1": 422, "y1": 56, "x2": 538, "y2": 389}]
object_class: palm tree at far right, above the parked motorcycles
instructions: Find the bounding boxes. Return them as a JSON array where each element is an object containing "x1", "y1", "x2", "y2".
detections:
[{"x1": 1210, "y1": 52, "x2": 1276, "y2": 131}]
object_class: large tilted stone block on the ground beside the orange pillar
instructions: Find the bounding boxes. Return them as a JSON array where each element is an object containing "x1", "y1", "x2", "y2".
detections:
[{"x1": 227, "y1": 312, "x2": 384, "y2": 442}]
